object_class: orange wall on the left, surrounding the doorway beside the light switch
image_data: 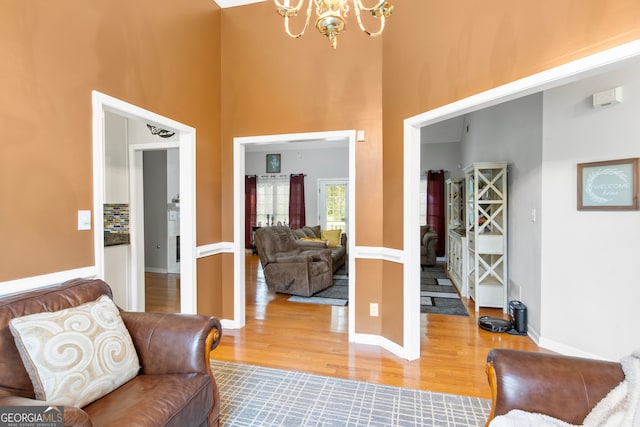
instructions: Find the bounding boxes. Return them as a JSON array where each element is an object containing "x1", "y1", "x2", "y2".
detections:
[{"x1": 0, "y1": 0, "x2": 221, "y2": 318}]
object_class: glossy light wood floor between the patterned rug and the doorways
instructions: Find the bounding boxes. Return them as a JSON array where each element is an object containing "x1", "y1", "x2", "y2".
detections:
[{"x1": 148, "y1": 255, "x2": 539, "y2": 399}]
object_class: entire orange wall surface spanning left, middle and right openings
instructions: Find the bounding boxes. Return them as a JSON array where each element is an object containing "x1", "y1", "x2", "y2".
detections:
[{"x1": 0, "y1": 0, "x2": 640, "y2": 344}]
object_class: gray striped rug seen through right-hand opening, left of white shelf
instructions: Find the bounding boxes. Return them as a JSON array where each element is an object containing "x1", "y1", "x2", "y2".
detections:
[{"x1": 420, "y1": 266, "x2": 469, "y2": 316}]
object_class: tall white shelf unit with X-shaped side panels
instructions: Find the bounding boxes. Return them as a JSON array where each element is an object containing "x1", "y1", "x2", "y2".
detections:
[{"x1": 464, "y1": 162, "x2": 509, "y2": 312}]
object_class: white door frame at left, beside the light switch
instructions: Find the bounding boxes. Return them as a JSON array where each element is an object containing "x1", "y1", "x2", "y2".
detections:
[{"x1": 92, "y1": 91, "x2": 197, "y2": 314}]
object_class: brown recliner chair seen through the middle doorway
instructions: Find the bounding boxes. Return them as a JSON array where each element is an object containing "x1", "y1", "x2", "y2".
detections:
[{"x1": 255, "y1": 226, "x2": 333, "y2": 297}]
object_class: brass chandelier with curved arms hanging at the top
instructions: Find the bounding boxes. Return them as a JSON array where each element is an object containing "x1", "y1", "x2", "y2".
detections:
[{"x1": 274, "y1": 0, "x2": 393, "y2": 49}]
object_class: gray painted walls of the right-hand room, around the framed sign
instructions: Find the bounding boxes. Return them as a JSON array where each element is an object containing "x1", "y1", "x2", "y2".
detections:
[{"x1": 423, "y1": 60, "x2": 640, "y2": 360}]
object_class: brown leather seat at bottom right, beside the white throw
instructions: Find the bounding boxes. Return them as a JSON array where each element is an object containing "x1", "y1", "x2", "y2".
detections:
[{"x1": 486, "y1": 349, "x2": 624, "y2": 426}]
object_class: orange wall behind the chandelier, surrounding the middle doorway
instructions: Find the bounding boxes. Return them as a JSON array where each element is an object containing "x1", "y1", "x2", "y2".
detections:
[{"x1": 222, "y1": 2, "x2": 383, "y2": 331}]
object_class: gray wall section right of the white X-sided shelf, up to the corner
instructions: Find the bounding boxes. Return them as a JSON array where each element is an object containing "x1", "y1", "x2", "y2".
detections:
[{"x1": 461, "y1": 93, "x2": 542, "y2": 342}]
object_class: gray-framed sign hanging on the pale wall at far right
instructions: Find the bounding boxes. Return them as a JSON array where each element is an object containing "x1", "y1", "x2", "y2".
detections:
[{"x1": 578, "y1": 158, "x2": 638, "y2": 210}]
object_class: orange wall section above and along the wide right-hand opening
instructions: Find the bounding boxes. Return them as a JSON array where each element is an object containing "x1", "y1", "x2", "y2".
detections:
[{"x1": 381, "y1": 0, "x2": 640, "y2": 343}]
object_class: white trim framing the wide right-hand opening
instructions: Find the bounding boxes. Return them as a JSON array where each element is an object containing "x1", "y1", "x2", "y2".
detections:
[{"x1": 403, "y1": 40, "x2": 640, "y2": 360}]
